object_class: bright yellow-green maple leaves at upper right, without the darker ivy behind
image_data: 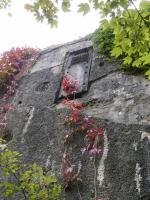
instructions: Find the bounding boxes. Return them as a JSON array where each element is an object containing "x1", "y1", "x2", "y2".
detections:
[{"x1": 108, "y1": 2, "x2": 150, "y2": 79}]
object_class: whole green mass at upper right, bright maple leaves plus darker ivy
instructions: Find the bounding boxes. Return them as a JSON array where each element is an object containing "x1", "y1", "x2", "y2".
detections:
[{"x1": 94, "y1": 1, "x2": 150, "y2": 80}]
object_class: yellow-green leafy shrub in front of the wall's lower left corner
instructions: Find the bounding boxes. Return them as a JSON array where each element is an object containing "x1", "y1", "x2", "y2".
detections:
[{"x1": 0, "y1": 139, "x2": 62, "y2": 200}]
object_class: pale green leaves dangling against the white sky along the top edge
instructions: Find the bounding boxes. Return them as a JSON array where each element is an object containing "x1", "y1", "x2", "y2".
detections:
[{"x1": 0, "y1": 0, "x2": 137, "y2": 27}]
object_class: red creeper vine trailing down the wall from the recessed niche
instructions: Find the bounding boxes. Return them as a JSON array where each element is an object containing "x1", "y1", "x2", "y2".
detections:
[{"x1": 62, "y1": 76, "x2": 104, "y2": 200}]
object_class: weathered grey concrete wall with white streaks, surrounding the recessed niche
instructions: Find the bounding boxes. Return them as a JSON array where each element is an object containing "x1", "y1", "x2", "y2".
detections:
[{"x1": 2, "y1": 39, "x2": 150, "y2": 200}]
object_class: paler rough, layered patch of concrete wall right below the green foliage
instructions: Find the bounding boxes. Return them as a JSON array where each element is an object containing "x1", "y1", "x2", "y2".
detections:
[{"x1": 84, "y1": 72, "x2": 150, "y2": 125}]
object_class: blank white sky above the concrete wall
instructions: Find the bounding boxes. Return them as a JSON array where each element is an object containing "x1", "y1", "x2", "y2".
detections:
[{"x1": 0, "y1": 0, "x2": 100, "y2": 53}]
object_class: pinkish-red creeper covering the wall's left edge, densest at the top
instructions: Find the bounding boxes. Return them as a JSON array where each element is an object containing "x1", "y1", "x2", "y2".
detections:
[{"x1": 0, "y1": 47, "x2": 39, "y2": 130}]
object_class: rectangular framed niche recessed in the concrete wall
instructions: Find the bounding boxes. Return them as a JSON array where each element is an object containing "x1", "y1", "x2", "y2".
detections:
[{"x1": 59, "y1": 46, "x2": 93, "y2": 98}]
